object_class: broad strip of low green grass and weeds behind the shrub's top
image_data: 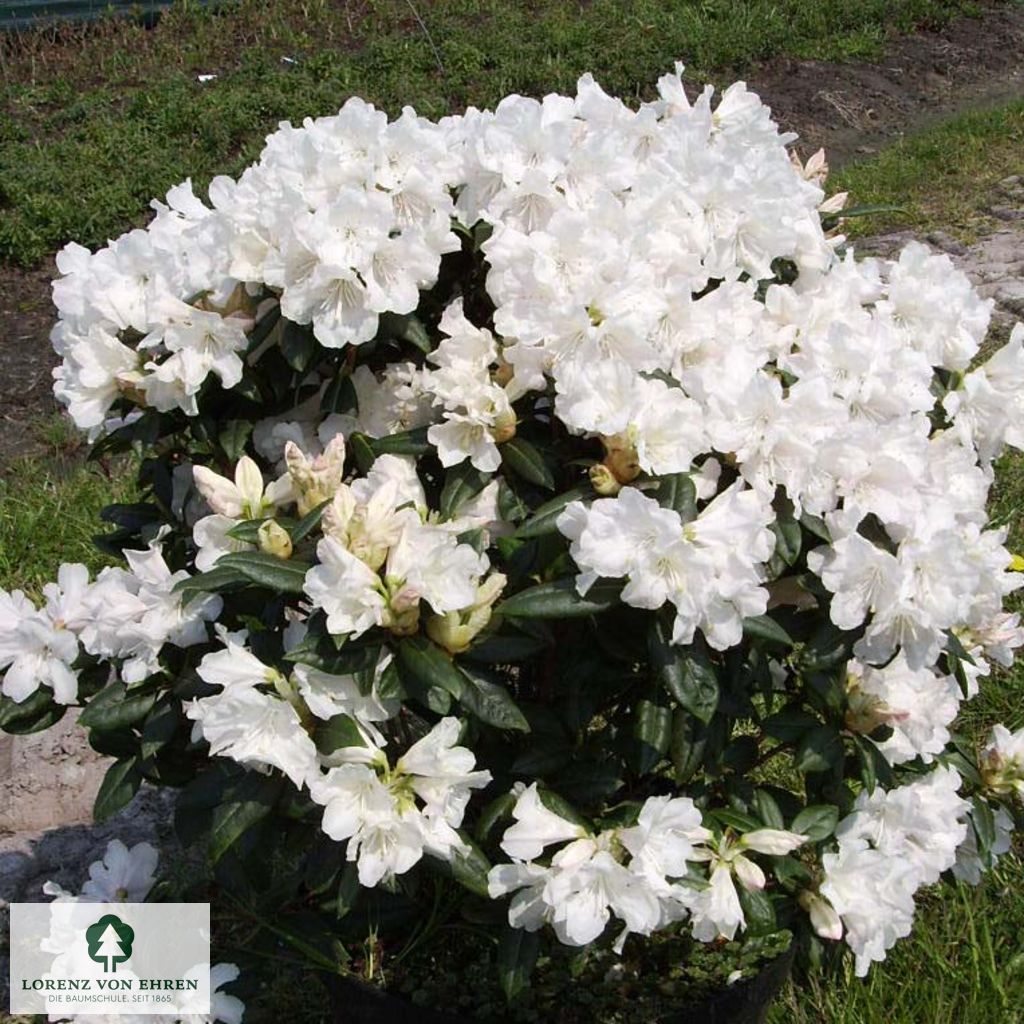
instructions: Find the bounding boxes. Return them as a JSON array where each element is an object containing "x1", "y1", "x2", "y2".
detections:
[{"x1": 0, "y1": 0, "x2": 984, "y2": 265}]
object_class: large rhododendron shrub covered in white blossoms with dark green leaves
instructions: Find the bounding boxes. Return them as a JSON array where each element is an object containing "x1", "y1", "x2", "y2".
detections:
[{"x1": 0, "y1": 71, "x2": 1024, "y2": 991}]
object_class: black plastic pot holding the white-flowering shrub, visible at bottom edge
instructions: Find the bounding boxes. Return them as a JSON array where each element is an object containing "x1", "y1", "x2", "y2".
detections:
[{"x1": 331, "y1": 946, "x2": 794, "y2": 1024}]
